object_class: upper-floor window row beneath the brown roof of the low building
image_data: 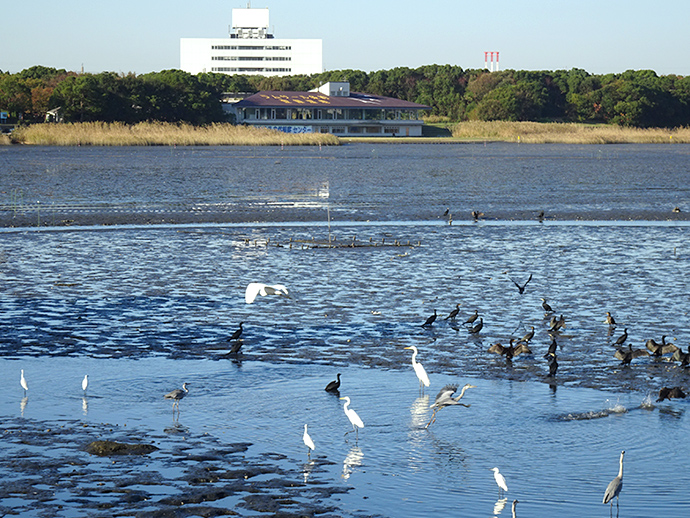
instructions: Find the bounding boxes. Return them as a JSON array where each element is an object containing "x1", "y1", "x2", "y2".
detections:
[{"x1": 242, "y1": 108, "x2": 417, "y2": 120}]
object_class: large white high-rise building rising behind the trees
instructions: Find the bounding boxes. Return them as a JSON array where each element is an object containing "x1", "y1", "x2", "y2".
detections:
[{"x1": 180, "y1": 7, "x2": 323, "y2": 76}]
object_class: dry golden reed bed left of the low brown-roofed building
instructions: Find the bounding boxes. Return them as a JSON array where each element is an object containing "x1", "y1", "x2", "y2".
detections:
[{"x1": 12, "y1": 122, "x2": 340, "y2": 146}]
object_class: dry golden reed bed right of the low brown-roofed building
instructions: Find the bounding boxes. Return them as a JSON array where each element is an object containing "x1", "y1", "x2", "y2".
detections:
[{"x1": 452, "y1": 121, "x2": 690, "y2": 144}]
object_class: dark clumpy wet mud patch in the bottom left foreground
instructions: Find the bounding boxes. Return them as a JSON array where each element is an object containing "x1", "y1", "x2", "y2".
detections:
[{"x1": 0, "y1": 418, "x2": 349, "y2": 517}]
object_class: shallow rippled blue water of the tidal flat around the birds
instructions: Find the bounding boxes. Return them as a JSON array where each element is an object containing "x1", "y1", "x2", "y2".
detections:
[{"x1": 0, "y1": 145, "x2": 690, "y2": 516}]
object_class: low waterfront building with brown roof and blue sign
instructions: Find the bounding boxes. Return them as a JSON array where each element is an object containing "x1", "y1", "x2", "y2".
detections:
[{"x1": 232, "y1": 81, "x2": 430, "y2": 136}]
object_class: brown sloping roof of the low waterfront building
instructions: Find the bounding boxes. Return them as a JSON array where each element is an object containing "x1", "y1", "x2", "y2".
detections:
[{"x1": 235, "y1": 91, "x2": 430, "y2": 110}]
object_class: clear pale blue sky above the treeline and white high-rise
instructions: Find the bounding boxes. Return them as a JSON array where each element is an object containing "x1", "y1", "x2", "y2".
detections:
[{"x1": 5, "y1": 0, "x2": 690, "y2": 75}]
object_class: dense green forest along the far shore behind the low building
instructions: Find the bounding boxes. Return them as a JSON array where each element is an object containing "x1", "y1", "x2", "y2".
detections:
[{"x1": 0, "y1": 65, "x2": 690, "y2": 128}]
